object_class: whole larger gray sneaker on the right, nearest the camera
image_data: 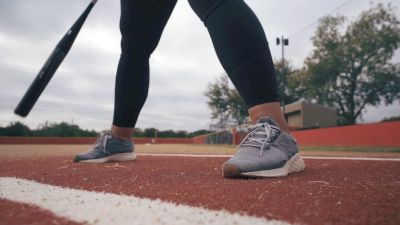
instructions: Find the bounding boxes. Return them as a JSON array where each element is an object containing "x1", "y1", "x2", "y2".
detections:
[{"x1": 222, "y1": 117, "x2": 305, "y2": 178}]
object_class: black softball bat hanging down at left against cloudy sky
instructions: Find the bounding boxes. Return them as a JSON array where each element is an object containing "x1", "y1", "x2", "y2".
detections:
[{"x1": 14, "y1": 0, "x2": 97, "y2": 117}]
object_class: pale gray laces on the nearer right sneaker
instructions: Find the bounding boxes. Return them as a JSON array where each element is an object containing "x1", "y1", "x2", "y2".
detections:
[{"x1": 239, "y1": 123, "x2": 280, "y2": 156}]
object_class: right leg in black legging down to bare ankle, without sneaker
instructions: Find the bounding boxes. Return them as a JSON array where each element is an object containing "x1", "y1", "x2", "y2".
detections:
[{"x1": 189, "y1": 0, "x2": 287, "y2": 131}]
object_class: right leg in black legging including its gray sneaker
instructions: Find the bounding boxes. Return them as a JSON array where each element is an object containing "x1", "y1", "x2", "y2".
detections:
[{"x1": 189, "y1": 0, "x2": 304, "y2": 177}]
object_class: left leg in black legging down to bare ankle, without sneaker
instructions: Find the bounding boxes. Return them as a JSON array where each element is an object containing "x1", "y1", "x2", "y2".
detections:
[{"x1": 112, "y1": 0, "x2": 177, "y2": 138}]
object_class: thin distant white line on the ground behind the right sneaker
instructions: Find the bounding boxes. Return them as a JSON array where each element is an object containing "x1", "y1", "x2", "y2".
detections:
[{"x1": 137, "y1": 153, "x2": 400, "y2": 161}]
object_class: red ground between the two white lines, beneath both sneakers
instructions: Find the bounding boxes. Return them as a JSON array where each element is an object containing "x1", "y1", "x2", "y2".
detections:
[{"x1": 0, "y1": 156, "x2": 400, "y2": 225}]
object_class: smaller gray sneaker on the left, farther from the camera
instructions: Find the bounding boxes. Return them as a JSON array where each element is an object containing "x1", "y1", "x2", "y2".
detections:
[{"x1": 74, "y1": 131, "x2": 136, "y2": 163}]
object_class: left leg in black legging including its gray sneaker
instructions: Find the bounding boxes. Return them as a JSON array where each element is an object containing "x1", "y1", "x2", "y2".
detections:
[{"x1": 74, "y1": 0, "x2": 176, "y2": 162}]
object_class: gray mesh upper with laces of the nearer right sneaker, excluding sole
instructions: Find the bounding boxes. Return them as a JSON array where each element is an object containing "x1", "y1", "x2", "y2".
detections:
[{"x1": 226, "y1": 117, "x2": 298, "y2": 173}]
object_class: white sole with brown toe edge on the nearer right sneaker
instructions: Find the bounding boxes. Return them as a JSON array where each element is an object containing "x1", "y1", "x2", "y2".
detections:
[{"x1": 222, "y1": 153, "x2": 305, "y2": 178}]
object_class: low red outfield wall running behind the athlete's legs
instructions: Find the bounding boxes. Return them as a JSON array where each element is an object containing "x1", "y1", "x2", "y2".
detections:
[{"x1": 0, "y1": 122, "x2": 400, "y2": 147}]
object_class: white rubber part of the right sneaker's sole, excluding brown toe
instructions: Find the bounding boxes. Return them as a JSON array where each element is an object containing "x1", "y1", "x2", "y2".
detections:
[{"x1": 241, "y1": 153, "x2": 306, "y2": 177}]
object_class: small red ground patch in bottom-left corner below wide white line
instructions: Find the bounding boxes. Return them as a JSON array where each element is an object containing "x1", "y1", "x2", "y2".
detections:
[{"x1": 0, "y1": 199, "x2": 79, "y2": 225}]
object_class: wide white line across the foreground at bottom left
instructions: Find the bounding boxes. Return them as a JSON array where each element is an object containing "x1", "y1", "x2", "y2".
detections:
[{"x1": 0, "y1": 177, "x2": 290, "y2": 225}]
